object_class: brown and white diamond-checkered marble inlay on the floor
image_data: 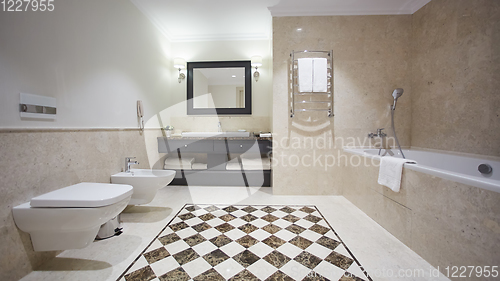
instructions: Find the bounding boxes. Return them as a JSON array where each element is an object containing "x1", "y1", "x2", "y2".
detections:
[{"x1": 117, "y1": 204, "x2": 372, "y2": 281}]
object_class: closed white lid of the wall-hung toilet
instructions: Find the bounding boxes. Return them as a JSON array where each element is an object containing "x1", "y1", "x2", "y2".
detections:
[{"x1": 30, "y1": 182, "x2": 133, "y2": 208}]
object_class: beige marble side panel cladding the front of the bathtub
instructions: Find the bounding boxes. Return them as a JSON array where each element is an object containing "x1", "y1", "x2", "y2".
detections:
[{"x1": 343, "y1": 158, "x2": 500, "y2": 280}]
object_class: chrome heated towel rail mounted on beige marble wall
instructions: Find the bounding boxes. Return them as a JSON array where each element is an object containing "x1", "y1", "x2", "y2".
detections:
[{"x1": 289, "y1": 50, "x2": 334, "y2": 118}]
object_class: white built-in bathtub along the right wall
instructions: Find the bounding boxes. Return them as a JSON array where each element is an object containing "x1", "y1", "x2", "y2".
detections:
[{"x1": 344, "y1": 148, "x2": 500, "y2": 193}]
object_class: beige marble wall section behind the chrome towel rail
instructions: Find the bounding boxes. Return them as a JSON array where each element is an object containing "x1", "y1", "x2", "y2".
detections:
[{"x1": 273, "y1": 15, "x2": 411, "y2": 194}]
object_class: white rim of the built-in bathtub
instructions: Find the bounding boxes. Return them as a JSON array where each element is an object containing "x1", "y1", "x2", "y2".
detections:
[{"x1": 343, "y1": 147, "x2": 500, "y2": 193}]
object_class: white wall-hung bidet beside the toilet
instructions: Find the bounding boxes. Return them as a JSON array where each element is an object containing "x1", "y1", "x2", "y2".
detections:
[{"x1": 111, "y1": 169, "x2": 175, "y2": 205}]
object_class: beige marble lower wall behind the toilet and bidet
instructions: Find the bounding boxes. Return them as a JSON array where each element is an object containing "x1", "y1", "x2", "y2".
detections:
[{"x1": 0, "y1": 130, "x2": 161, "y2": 280}]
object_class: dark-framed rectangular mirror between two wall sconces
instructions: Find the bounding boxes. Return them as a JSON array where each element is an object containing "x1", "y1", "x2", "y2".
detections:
[{"x1": 187, "y1": 61, "x2": 252, "y2": 115}]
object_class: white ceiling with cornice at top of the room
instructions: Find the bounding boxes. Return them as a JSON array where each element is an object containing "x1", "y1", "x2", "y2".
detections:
[{"x1": 130, "y1": 0, "x2": 430, "y2": 42}]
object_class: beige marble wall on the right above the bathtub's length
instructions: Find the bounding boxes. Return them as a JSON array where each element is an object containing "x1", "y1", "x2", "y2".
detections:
[{"x1": 411, "y1": 0, "x2": 500, "y2": 156}]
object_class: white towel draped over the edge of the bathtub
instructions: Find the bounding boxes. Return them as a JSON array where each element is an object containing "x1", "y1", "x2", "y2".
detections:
[{"x1": 378, "y1": 156, "x2": 415, "y2": 192}]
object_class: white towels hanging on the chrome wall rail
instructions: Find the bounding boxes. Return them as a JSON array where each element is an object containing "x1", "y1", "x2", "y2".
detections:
[{"x1": 297, "y1": 58, "x2": 328, "y2": 93}]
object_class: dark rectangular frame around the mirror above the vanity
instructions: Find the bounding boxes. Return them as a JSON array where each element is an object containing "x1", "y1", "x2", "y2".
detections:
[{"x1": 187, "y1": 61, "x2": 252, "y2": 115}]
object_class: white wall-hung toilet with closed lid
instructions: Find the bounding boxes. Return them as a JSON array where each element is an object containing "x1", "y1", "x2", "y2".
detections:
[{"x1": 12, "y1": 183, "x2": 133, "y2": 251}]
